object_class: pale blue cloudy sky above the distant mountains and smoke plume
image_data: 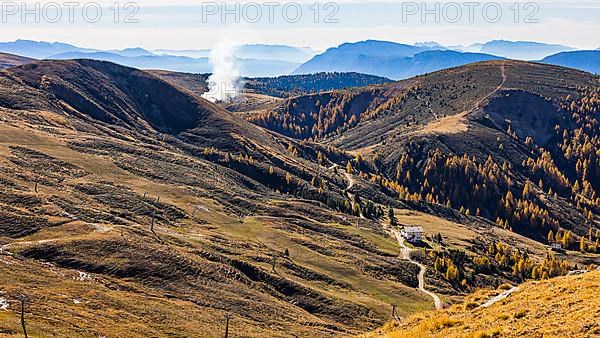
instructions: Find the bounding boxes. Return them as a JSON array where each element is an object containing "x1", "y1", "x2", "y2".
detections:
[{"x1": 0, "y1": 0, "x2": 600, "y2": 51}]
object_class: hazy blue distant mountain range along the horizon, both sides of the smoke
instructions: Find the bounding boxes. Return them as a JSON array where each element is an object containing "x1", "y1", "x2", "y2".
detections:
[{"x1": 0, "y1": 40, "x2": 600, "y2": 80}]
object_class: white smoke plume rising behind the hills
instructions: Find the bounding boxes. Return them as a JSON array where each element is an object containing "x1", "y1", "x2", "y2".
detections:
[{"x1": 202, "y1": 40, "x2": 243, "y2": 102}]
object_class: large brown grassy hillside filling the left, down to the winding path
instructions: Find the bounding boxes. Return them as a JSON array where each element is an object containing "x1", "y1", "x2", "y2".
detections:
[{"x1": 0, "y1": 60, "x2": 440, "y2": 337}]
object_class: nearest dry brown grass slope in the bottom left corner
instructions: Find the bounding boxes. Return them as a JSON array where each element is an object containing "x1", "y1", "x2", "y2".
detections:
[{"x1": 0, "y1": 250, "x2": 272, "y2": 337}]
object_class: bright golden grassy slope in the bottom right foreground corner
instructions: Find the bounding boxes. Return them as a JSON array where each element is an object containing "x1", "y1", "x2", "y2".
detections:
[{"x1": 361, "y1": 272, "x2": 600, "y2": 338}]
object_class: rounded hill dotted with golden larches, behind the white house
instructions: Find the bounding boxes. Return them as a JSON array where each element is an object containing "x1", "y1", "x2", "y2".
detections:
[{"x1": 249, "y1": 61, "x2": 600, "y2": 251}]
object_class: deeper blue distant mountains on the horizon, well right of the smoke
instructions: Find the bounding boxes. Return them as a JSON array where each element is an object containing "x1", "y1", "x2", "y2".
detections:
[{"x1": 294, "y1": 40, "x2": 600, "y2": 80}]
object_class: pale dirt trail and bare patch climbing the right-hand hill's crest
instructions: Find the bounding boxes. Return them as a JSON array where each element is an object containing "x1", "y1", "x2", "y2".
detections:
[{"x1": 413, "y1": 64, "x2": 506, "y2": 134}]
